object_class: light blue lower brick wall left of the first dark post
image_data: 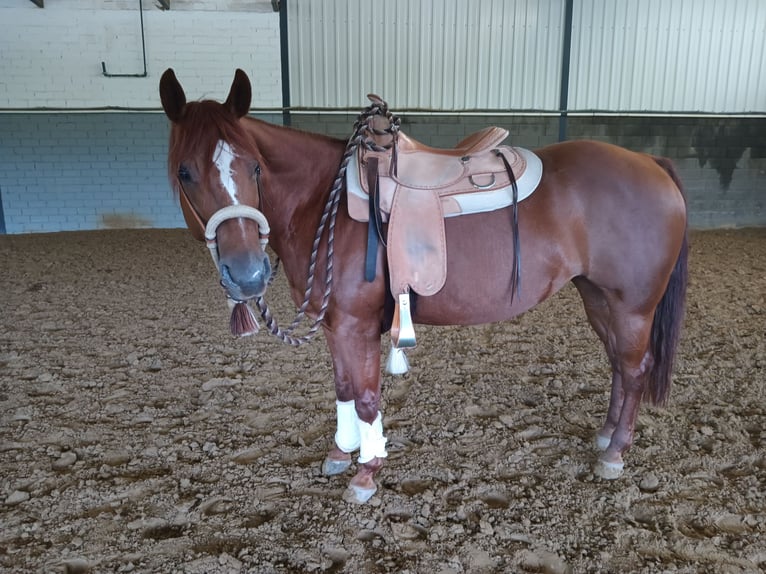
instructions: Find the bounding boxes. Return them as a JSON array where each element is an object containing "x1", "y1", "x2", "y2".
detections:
[{"x1": 0, "y1": 113, "x2": 281, "y2": 233}]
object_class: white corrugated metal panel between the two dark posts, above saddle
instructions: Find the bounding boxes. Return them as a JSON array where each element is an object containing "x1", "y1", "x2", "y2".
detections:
[{"x1": 288, "y1": 0, "x2": 564, "y2": 110}]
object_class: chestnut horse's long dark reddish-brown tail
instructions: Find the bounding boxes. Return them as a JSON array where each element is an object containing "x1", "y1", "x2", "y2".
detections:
[{"x1": 645, "y1": 157, "x2": 689, "y2": 405}]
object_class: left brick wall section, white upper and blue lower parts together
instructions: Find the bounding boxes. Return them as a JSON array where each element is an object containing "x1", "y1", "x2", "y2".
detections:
[{"x1": 0, "y1": 0, "x2": 282, "y2": 233}]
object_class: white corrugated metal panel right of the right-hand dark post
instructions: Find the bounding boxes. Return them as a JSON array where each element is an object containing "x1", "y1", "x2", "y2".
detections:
[{"x1": 569, "y1": 0, "x2": 766, "y2": 113}]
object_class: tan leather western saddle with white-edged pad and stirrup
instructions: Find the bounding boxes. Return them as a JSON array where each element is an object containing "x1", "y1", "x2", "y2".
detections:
[{"x1": 346, "y1": 95, "x2": 542, "y2": 349}]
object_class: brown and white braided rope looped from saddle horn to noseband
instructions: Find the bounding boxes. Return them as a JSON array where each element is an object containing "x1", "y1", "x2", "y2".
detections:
[{"x1": 255, "y1": 100, "x2": 400, "y2": 347}]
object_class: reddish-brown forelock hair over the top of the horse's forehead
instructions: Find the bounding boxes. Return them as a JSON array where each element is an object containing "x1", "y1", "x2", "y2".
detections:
[{"x1": 168, "y1": 100, "x2": 258, "y2": 194}]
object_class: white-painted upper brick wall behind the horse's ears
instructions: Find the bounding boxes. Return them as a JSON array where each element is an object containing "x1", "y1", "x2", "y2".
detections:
[{"x1": 0, "y1": 0, "x2": 282, "y2": 109}]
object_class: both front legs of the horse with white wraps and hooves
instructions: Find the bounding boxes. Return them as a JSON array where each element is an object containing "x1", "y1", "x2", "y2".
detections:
[{"x1": 322, "y1": 322, "x2": 386, "y2": 503}]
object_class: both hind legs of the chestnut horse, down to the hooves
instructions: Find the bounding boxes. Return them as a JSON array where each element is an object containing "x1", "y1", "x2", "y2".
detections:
[{"x1": 574, "y1": 277, "x2": 653, "y2": 479}]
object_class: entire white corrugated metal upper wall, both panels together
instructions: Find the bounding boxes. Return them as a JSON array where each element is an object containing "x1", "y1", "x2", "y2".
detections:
[{"x1": 288, "y1": 0, "x2": 766, "y2": 113}]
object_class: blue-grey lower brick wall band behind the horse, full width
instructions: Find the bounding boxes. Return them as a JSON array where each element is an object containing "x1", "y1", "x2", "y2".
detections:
[{"x1": 0, "y1": 109, "x2": 766, "y2": 233}]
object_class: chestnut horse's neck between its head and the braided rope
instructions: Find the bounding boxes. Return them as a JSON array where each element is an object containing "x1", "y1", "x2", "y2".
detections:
[{"x1": 253, "y1": 120, "x2": 344, "y2": 289}]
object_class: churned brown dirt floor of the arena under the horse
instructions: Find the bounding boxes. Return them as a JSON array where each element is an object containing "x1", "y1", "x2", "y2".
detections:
[{"x1": 0, "y1": 229, "x2": 766, "y2": 574}]
